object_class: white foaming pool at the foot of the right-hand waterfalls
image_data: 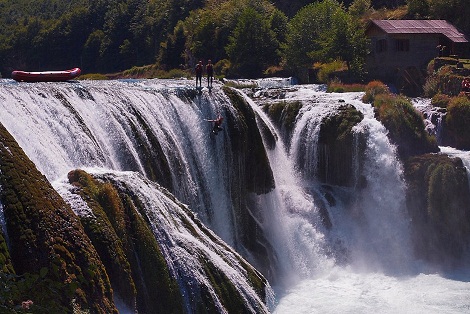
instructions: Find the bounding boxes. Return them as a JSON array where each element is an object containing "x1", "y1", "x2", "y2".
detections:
[{"x1": 273, "y1": 268, "x2": 470, "y2": 314}]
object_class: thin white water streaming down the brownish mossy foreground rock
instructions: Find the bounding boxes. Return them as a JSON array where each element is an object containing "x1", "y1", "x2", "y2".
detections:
[{"x1": 55, "y1": 168, "x2": 269, "y2": 313}]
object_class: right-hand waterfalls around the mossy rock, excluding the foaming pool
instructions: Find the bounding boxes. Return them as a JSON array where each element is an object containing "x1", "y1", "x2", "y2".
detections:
[{"x1": 254, "y1": 86, "x2": 411, "y2": 277}]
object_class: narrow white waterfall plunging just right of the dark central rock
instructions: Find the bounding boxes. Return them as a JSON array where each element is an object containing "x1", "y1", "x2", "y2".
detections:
[{"x1": 239, "y1": 91, "x2": 334, "y2": 285}]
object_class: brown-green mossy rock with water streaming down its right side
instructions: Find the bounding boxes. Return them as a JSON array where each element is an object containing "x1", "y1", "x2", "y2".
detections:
[{"x1": 68, "y1": 170, "x2": 183, "y2": 313}]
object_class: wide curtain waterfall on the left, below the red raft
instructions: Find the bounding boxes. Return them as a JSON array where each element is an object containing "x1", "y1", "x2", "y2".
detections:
[{"x1": 0, "y1": 80, "x2": 236, "y2": 245}]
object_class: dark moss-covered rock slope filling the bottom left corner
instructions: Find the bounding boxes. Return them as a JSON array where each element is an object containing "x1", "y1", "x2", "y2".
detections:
[{"x1": 0, "y1": 125, "x2": 117, "y2": 313}]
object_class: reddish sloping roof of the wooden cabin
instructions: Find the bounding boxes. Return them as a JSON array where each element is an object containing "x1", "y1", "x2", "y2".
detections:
[{"x1": 368, "y1": 20, "x2": 468, "y2": 43}]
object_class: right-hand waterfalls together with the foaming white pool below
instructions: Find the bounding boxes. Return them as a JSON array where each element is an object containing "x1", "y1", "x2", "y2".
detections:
[{"x1": 248, "y1": 86, "x2": 470, "y2": 314}]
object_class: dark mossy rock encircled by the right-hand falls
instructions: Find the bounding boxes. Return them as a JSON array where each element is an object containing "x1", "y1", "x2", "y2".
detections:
[{"x1": 316, "y1": 105, "x2": 365, "y2": 186}]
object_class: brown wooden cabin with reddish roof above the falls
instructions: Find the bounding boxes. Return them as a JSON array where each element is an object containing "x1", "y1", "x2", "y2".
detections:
[{"x1": 366, "y1": 20, "x2": 469, "y2": 93}]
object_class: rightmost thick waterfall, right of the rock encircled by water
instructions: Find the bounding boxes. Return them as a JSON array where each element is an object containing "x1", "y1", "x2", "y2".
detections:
[{"x1": 346, "y1": 102, "x2": 412, "y2": 272}]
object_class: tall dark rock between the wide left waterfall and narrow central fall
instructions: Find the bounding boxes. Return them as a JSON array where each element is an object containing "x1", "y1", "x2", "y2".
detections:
[{"x1": 223, "y1": 87, "x2": 277, "y2": 274}]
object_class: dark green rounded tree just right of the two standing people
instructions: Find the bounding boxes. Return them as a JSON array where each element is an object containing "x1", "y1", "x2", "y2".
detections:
[{"x1": 226, "y1": 7, "x2": 278, "y2": 78}]
